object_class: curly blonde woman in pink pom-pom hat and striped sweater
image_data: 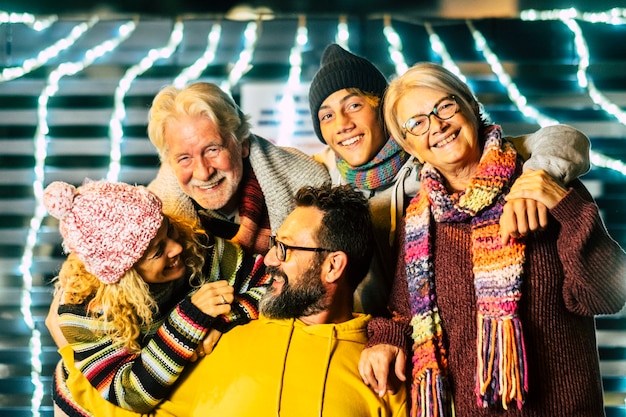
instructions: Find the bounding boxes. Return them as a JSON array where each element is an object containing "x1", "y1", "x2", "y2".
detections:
[{"x1": 44, "y1": 181, "x2": 265, "y2": 416}]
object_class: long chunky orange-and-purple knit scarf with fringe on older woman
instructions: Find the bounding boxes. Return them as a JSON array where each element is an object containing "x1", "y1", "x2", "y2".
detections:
[{"x1": 405, "y1": 126, "x2": 528, "y2": 417}]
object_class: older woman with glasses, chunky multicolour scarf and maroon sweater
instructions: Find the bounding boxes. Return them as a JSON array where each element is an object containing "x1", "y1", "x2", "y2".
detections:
[{"x1": 359, "y1": 63, "x2": 626, "y2": 417}]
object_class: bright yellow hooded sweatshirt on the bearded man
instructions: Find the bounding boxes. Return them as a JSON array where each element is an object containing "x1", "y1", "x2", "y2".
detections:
[{"x1": 57, "y1": 313, "x2": 408, "y2": 417}]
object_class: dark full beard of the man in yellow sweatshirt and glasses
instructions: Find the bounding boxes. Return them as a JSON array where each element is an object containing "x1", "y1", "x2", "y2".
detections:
[{"x1": 259, "y1": 260, "x2": 328, "y2": 319}]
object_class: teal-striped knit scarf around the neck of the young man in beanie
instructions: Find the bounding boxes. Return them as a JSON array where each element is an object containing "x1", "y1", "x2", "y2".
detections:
[{"x1": 337, "y1": 138, "x2": 411, "y2": 190}]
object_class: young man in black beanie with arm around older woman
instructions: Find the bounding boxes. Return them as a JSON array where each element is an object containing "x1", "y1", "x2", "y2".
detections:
[{"x1": 309, "y1": 44, "x2": 589, "y2": 316}]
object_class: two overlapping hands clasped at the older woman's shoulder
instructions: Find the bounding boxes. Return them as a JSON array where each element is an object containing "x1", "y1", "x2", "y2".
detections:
[{"x1": 500, "y1": 170, "x2": 567, "y2": 245}]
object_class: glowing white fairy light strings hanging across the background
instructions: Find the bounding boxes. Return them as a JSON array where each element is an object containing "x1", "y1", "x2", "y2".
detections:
[{"x1": 0, "y1": 8, "x2": 626, "y2": 416}]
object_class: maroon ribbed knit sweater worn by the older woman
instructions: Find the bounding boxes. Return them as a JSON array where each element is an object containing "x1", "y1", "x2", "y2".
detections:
[{"x1": 368, "y1": 181, "x2": 626, "y2": 417}]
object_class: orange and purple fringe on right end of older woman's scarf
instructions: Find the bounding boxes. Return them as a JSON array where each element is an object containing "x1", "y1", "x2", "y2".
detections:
[{"x1": 476, "y1": 314, "x2": 528, "y2": 410}]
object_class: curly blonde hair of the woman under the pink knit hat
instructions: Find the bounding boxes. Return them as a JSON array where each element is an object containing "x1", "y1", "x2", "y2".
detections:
[{"x1": 55, "y1": 216, "x2": 207, "y2": 352}]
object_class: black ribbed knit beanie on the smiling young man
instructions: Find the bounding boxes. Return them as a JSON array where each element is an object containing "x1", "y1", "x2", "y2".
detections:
[{"x1": 309, "y1": 43, "x2": 387, "y2": 143}]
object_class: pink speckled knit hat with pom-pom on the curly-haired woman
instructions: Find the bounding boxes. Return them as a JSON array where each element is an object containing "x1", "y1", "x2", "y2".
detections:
[{"x1": 43, "y1": 181, "x2": 163, "y2": 284}]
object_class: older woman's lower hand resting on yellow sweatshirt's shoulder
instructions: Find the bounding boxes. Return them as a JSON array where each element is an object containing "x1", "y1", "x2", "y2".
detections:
[{"x1": 359, "y1": 345, "x2": 406, "y2": 397}]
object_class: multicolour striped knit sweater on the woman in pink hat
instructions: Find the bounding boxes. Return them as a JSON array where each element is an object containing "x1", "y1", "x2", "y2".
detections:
[{"x1": 53, "y1": 239, "x2": 266, "y2": 417}]
